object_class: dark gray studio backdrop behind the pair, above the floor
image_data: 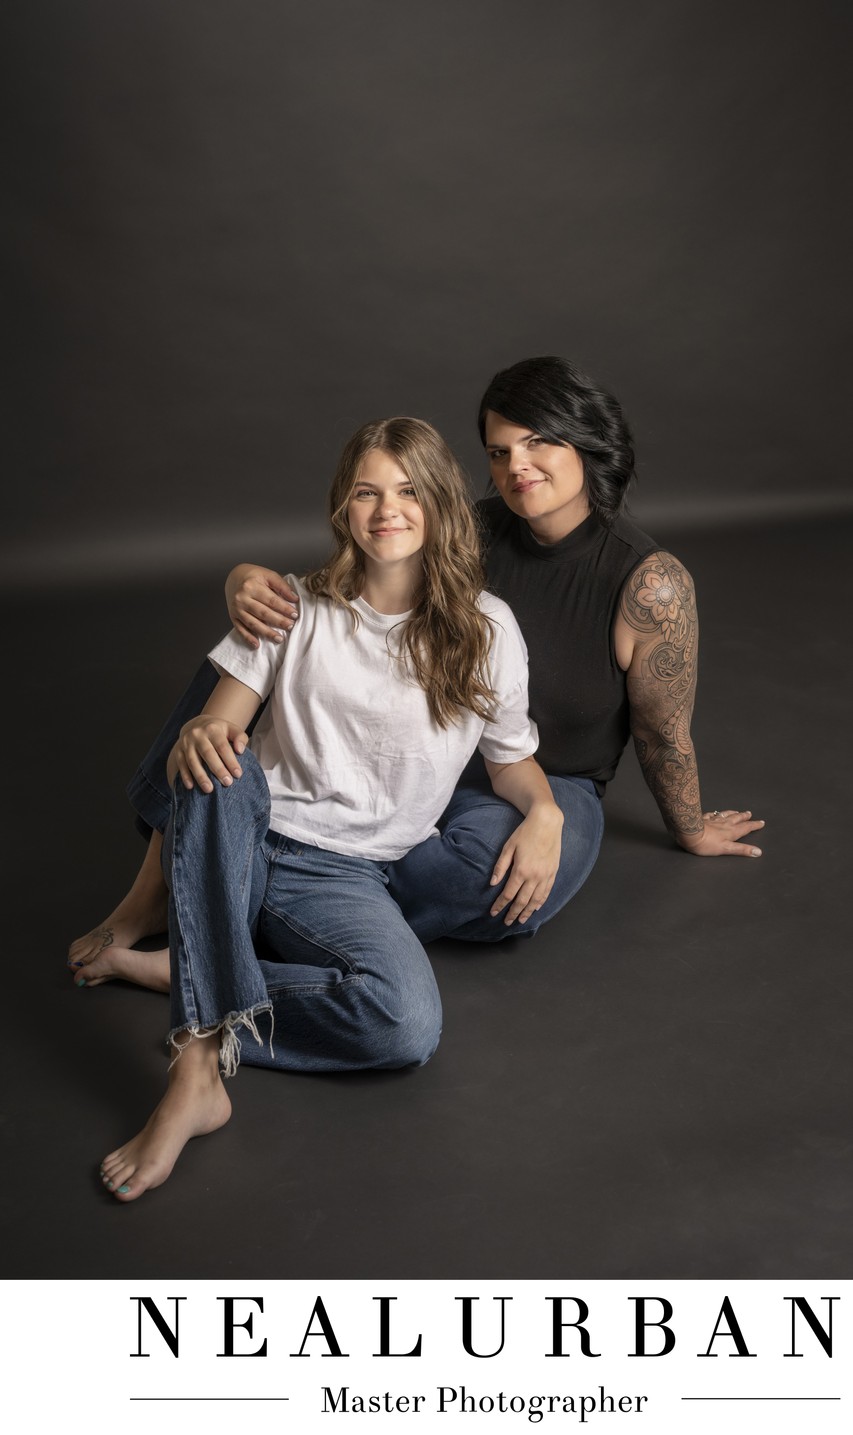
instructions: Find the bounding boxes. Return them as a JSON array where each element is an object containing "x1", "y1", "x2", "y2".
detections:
[{"x1": 0, "y1": 0, "x2": 849, "y2": 584}]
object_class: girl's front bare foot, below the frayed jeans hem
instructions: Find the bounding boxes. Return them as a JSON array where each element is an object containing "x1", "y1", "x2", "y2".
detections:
[{"x1": 101, "y1": 1035, "x2": 231, "y2": 1201}]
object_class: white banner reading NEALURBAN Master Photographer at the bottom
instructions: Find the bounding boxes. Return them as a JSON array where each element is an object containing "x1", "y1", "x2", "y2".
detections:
[{"x1": 3, "y1": 1277, "x2": 853, "y2": 1435}]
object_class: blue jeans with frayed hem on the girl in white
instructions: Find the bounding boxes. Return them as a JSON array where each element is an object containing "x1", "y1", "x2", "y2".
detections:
[{"x1": 162, "y1": 752, "x2": 441, "y2": 1073}]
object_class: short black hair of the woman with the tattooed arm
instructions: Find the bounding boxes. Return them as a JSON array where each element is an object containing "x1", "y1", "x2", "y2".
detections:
[{"x1": 478, "y1": 354, "x2": 633, "y2": 522}]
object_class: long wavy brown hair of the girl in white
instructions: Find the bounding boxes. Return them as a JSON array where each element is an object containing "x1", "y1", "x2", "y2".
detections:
[{"x1": 304, "y1": 418, "x2": 495, "y2": 728}]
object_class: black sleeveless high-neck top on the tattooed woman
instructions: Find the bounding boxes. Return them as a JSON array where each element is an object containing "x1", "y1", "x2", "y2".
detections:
[{"x1": 477, "y1": 498, "x2": 661, "y2": 794}]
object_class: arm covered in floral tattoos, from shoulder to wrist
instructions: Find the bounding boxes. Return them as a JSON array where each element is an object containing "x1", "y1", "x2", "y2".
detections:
[{"x1": 620, "y1": 552, "x2": 704, "y2": 841}]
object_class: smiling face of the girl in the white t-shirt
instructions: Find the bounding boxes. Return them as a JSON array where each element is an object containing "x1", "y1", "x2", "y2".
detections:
[{"x1": 346, "y1": 449, "x2": 427, "y2": 567}]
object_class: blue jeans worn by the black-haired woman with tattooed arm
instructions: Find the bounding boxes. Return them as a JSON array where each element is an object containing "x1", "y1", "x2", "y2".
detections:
[{"x1": 128, "y1": 660, "x2": 605, "y2": 941}]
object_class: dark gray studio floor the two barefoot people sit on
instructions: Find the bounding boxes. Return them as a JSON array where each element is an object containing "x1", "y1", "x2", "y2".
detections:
[{"x1": 3, "y1": 522, "x2": 853, "y2": 1279}]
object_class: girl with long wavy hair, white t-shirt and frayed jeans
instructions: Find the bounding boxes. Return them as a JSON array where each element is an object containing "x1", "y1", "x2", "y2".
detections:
[{"x1": 93, "y1": 418, "x2": 563, "y2": 1201}]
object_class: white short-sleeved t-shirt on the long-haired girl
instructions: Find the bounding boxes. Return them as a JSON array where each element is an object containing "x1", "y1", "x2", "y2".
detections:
[{"x1": 208, "y1": 574, "x2": 539, "y2": 862}]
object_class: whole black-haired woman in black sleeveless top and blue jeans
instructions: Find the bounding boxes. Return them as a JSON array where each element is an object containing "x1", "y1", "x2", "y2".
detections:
[{"x1": 70, "y1": 356, "x2": 764, "y2": 987}]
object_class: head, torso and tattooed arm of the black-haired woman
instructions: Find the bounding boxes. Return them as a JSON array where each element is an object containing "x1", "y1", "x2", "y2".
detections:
[{"x1": 468, "y1": 357, "x2": 764, "y2": 857}]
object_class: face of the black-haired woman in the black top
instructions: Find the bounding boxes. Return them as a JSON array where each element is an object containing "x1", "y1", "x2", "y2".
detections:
[{"x1": 485, "y1": 409, "x2": 590, "y2": 542}]
